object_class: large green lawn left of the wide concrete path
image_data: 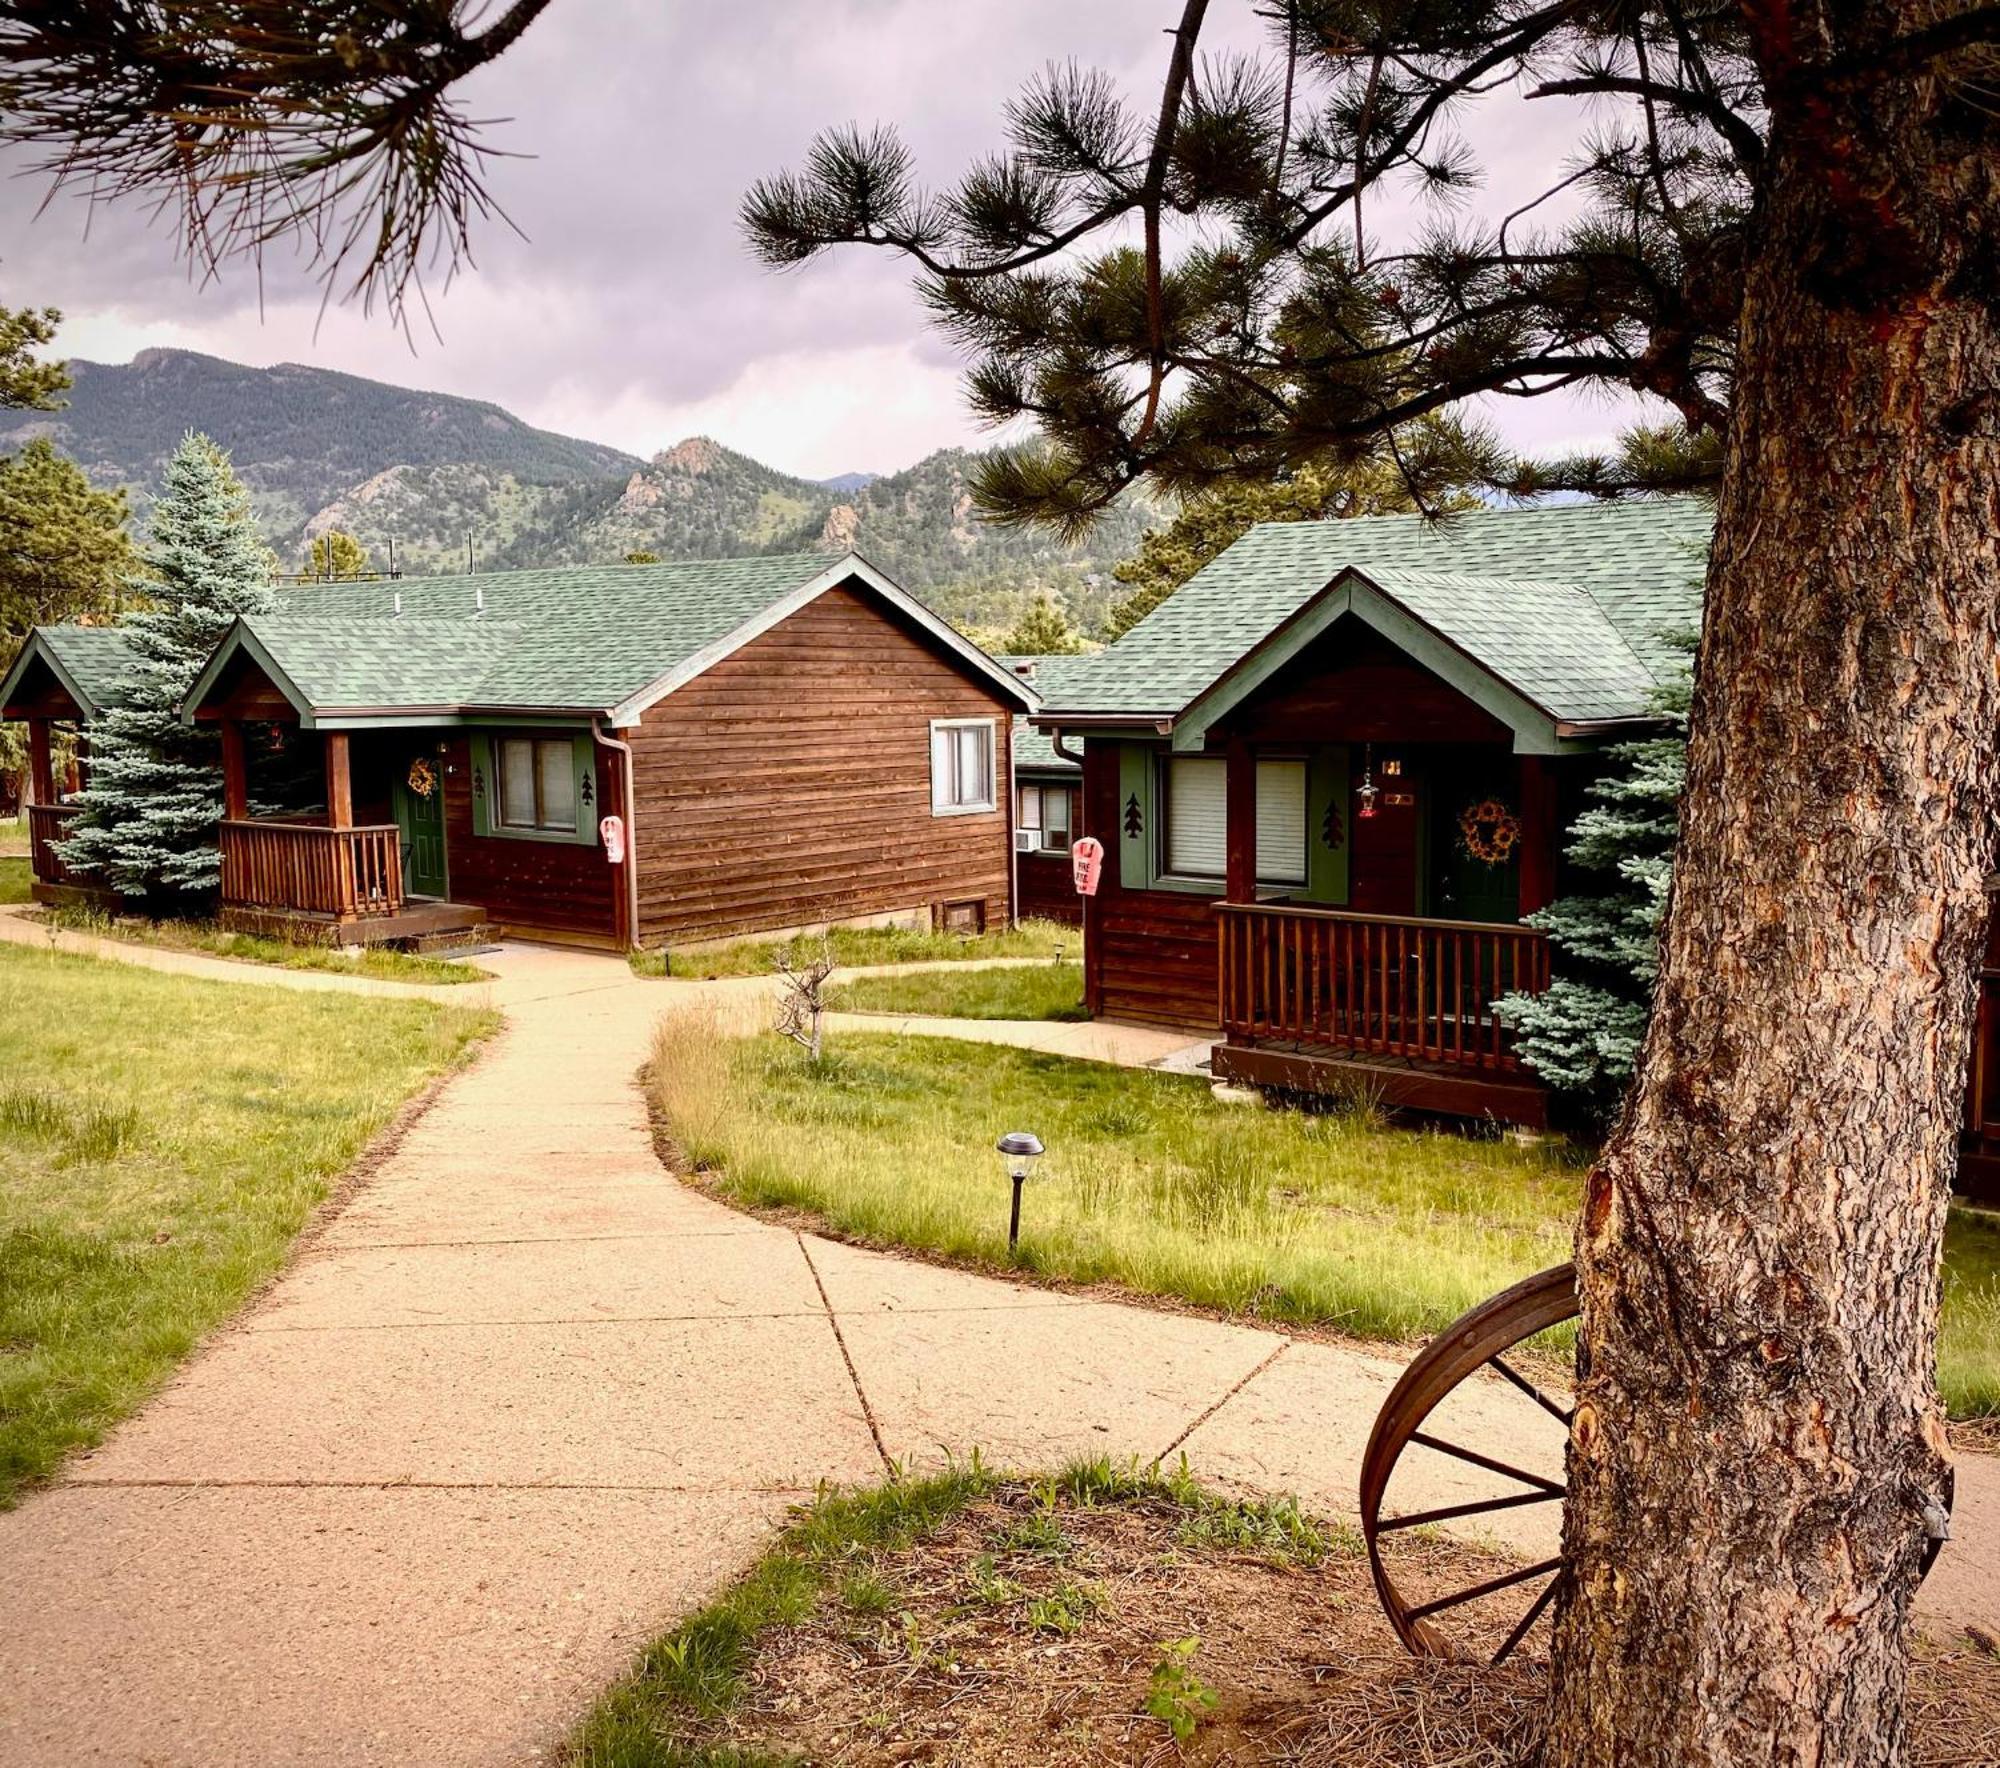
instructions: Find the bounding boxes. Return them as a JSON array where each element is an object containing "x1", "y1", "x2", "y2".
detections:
[{"x1": 0, "y1": 946, "x2": 496, "y2": 1508}]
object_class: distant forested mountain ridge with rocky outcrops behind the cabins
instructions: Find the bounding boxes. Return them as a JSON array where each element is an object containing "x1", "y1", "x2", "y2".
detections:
[{"x1": 0, "y1": 350, "x2": 1158, "y2": 630}]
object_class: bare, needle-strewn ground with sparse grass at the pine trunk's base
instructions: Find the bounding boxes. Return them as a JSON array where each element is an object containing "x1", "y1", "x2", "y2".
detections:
[{"x1": 568, "y1": 1464, "x2": 2000, "y2": 1768}]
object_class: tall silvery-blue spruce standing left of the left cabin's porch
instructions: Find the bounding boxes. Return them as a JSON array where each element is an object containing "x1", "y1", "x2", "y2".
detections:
[{"x1": 64, "y1": 432, "x2": 272, "y2": 912}]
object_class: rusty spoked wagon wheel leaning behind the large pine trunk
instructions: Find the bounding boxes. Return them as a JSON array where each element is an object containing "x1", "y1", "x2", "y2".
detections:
[{"x1": 1360, "y1": 1264, "x2": 1954, "y2": 1664}]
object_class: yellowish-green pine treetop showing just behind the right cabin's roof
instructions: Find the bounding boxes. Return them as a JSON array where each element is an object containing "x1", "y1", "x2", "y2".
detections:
[{"x1": 1104, "y1": 462, "x2": 1478, "y2": 638}]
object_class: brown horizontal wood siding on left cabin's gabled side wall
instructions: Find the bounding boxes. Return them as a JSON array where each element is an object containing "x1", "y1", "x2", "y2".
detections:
[{"x1": 624, "y1": 586, "x2": 1012, "y2": 946}]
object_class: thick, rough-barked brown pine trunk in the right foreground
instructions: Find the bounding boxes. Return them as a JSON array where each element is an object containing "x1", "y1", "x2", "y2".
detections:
[{"x1": 1546, "y1": 17, "x2": 2000, "y2": 1768}]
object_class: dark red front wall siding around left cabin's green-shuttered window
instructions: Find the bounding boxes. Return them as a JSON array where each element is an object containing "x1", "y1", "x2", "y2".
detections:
[{"x1": 444, "y1": 734, "x2": 620, "y2": 946}]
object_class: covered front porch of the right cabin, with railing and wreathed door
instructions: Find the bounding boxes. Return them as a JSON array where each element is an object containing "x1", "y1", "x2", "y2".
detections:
[{"x1": 1212, "y1": 732, "x2": 1560, "y2": 1128}]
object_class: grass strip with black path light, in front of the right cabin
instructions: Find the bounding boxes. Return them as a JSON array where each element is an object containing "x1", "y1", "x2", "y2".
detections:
[{"x1": 652, "y1": 1014, "x2": 2000, "y2": 1416}]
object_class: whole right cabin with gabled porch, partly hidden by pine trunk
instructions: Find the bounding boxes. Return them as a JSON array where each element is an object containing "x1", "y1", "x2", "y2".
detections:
[{"x1": 1032, "y1": 500, "x2": 1710, "y2": 1124}]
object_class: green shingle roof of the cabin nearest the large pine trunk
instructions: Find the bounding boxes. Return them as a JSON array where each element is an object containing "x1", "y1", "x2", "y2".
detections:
[{"x1": 1040, "y1": 498, "x2": 1714, "y2": 720}]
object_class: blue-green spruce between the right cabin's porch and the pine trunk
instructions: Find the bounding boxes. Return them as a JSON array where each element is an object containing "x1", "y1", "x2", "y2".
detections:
[{"x1": 1496, "y1": 634, "x2": 1694, "y2": 1120}]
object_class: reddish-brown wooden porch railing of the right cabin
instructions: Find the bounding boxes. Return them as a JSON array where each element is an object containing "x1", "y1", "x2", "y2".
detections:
[{"x1": 1216, "y1": 902, "x2": 1548, "y2": 1072}]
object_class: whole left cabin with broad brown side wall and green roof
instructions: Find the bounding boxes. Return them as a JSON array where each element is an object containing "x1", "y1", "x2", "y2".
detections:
[{"x1": 8, "y1": 554, "x2": 1034, "y2": 948}]
